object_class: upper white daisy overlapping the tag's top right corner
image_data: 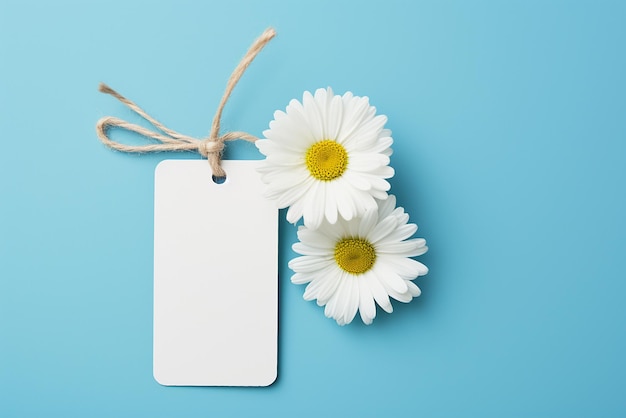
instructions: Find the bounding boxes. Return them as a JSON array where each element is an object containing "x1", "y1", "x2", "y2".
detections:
[{"x1": 256, "y1": 88, "x2": 394, "y2": 228}]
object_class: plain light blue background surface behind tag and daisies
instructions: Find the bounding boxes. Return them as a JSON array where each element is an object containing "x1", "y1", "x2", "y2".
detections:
[{"x1": 0, "y1": 0, "x2": 626, "y2": 417}]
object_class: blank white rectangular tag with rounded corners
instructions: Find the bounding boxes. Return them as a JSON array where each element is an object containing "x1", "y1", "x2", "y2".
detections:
[{"x1": 153, "y1": 160, "x2": 278, "y2": 386}]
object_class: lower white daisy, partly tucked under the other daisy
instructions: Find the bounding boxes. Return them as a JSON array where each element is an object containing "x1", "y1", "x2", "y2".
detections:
[{"x1": 289, "y1": 195, "x2": 428, "y2": 325}]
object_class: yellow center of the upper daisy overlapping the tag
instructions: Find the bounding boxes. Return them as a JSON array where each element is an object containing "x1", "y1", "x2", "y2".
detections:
[{"x1": 306, "y1": 139, "x2": 348, "y2": 181}]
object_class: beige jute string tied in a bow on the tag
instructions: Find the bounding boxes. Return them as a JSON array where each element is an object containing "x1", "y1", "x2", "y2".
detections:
[{"x1": 96, "y1": 28, "x2": 276, "y2": 177}]
